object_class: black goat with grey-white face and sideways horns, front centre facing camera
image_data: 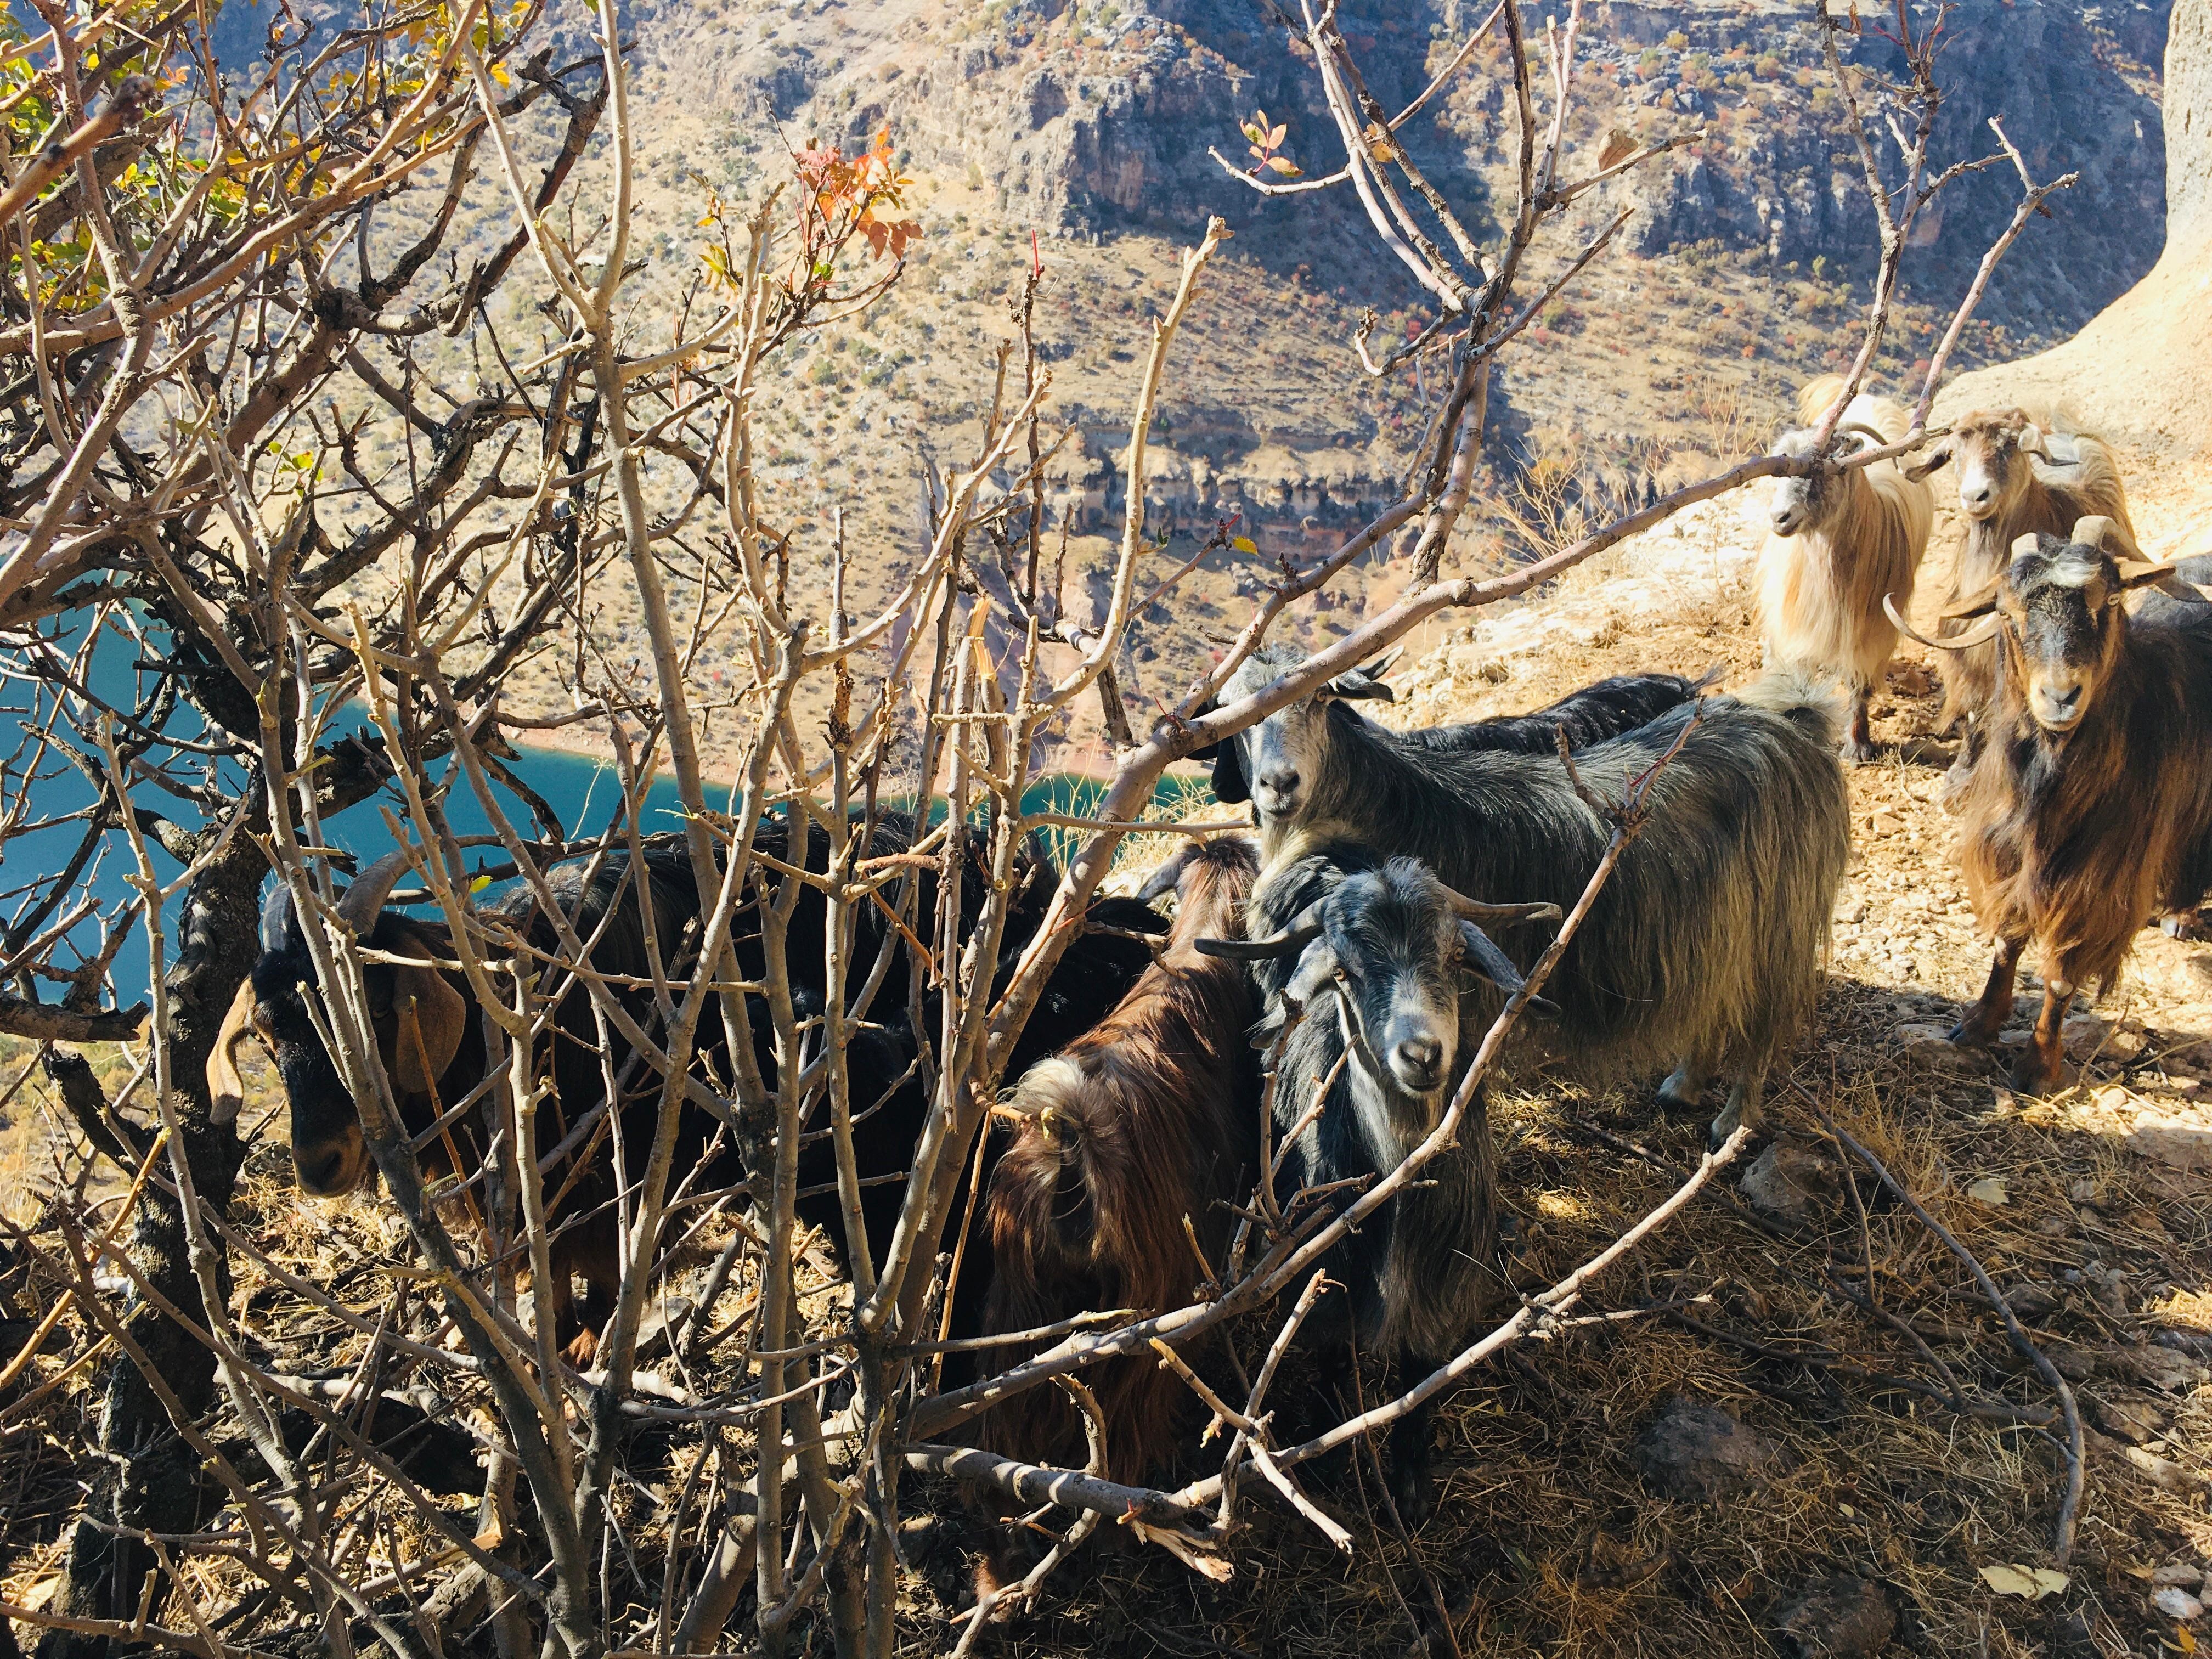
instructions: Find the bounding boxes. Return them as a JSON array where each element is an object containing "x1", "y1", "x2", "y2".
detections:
[{"x1": 1199, "y1": 843, "x2": 1560, "y2": 1522}]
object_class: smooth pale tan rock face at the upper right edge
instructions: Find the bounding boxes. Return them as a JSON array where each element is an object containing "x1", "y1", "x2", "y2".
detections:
[{"x1": 1936, "y1": 0, "x2": 2212, "y2": 460}]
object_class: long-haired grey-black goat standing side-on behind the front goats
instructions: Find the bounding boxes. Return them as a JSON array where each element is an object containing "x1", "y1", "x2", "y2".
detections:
[{"x1": 1223, "y1": 646, "x2": 1849, "y2": 1137}]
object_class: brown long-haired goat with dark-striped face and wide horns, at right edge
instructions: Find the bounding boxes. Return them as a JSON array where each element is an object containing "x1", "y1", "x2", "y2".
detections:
[{"x1": 1876, "y1": 515, "x2": 2212, "y2": 1095}]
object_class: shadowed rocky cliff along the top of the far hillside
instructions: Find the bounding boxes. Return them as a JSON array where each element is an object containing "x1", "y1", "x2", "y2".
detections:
[{"x1": 663, "y1": 0, "x2": 2170, "y2": 336}]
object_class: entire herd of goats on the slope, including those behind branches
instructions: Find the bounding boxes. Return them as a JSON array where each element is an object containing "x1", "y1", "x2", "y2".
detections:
[{"x1": 210, "y1": 383, "x2": 2212, "y2": 1520}]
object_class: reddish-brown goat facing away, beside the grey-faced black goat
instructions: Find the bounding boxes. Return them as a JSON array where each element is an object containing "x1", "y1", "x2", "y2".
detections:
[{"x1": 984, "y1": 836, "x2": 1259, "y2": 1482}]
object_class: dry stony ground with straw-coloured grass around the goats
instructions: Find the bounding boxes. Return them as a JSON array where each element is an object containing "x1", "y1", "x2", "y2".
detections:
[{"x1": 0, "y1": 471, "x2": 2212, "y2": 1659}]
